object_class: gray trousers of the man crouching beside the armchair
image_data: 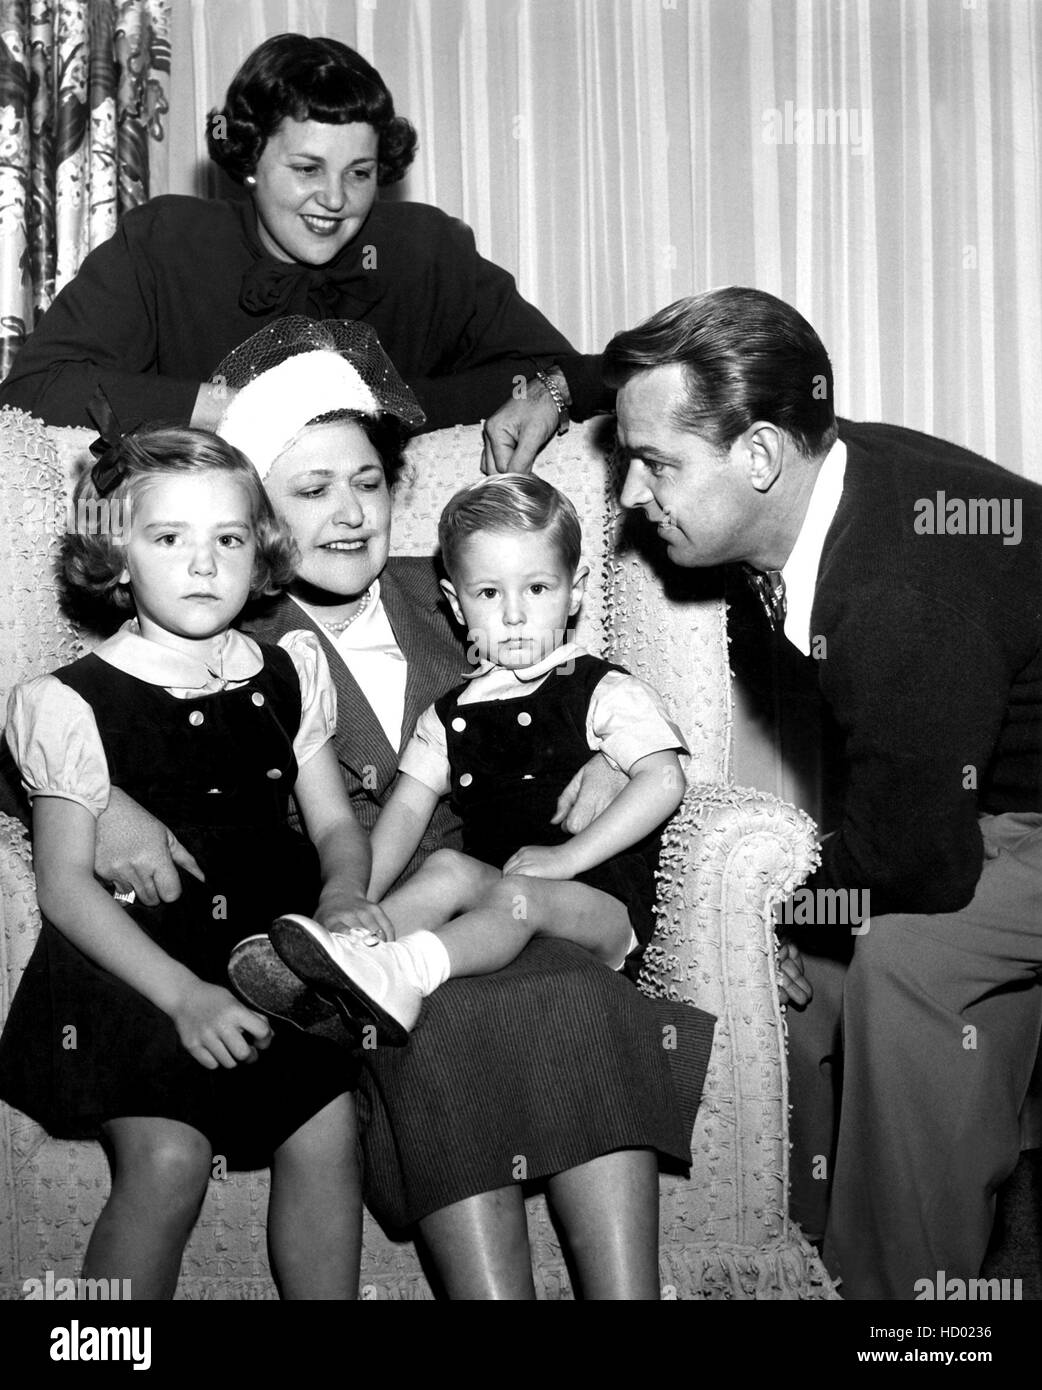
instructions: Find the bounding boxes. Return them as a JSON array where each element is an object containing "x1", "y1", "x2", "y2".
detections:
[{"x1": 789, "y1": 813, "x2": 1042, "y2": 1300}]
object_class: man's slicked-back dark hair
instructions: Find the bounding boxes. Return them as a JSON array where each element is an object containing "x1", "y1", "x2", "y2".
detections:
[{"x1": 603, "y1": 286, "x2": 836, "y2": 457}]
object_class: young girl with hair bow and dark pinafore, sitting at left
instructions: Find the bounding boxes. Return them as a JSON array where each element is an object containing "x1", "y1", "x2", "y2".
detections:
[{"x1": 0, "y1": 430, "x2": 370, "y2": 1298}]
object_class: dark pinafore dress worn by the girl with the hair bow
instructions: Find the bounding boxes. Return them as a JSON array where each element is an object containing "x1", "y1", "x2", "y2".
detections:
[{"x1": 0, "y1": 645, "x2": 357, "y2": 1168}]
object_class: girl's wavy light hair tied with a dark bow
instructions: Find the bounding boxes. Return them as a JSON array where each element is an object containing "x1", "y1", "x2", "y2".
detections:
[{"x1": 61, "y1": 428, "x2": 299, "y2": 609}]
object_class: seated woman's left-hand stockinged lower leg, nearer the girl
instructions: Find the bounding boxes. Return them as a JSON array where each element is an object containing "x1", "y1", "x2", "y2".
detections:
[{"x1": 420, "y1": 1187, "x2": 535, "y2": 1301}]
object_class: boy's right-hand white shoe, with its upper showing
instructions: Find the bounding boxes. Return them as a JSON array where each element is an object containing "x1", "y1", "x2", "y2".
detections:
[{"x1": 270, "y1": 913, "x2": 424, "y2": 1047}]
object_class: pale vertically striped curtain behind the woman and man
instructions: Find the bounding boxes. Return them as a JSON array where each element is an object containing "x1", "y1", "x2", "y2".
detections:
[{"x1": 171, "y1": 0, "x2": 1042, "y2": 481}]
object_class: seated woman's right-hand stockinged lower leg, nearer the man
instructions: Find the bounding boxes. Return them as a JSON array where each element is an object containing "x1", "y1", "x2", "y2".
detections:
[{"x1": 547, "y1": 1148, "x2": 660, "y2": 1301}]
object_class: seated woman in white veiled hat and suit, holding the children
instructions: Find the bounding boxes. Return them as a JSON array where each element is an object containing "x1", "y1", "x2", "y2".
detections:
[{"x1": 89, "y1": 320, "x2": 713, "y2": 1298}]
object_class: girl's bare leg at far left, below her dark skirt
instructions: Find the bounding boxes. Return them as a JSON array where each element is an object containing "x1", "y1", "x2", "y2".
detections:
[{"x1": 83, "y1": 1115, "x2": 213, "y2": 1300}]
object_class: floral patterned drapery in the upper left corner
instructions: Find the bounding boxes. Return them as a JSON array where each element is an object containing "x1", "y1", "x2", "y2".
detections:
[{"x1": 0, "y1": 0, "x2": 169, "y2": 375}]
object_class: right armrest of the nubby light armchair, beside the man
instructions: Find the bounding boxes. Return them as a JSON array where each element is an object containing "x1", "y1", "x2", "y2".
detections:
[{"x1": 640, "y1": 785, "x2": 818, "y2": 1262}]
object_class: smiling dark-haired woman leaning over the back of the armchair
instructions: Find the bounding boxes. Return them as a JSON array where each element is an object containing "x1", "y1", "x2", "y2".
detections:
[{"x1": 0, "y1": 33, "x2": 604, "y2": 471}]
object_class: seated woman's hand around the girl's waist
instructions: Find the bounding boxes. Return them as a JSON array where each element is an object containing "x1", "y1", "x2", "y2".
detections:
[{"x1": 94, "y1": 787, "x2": 206, "y2": 908}]
